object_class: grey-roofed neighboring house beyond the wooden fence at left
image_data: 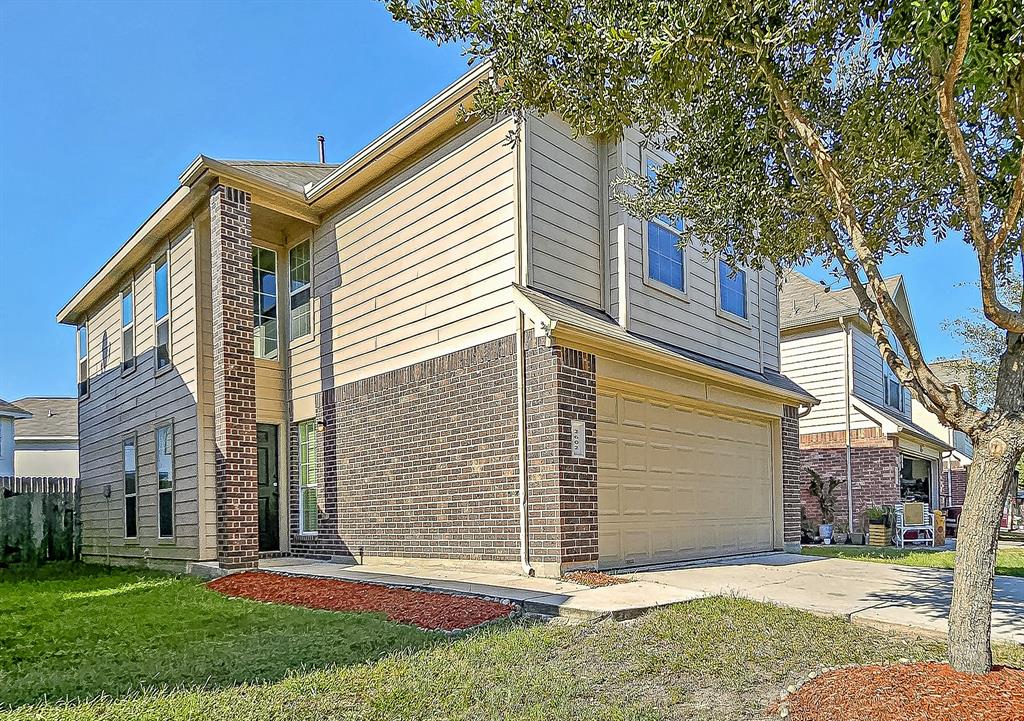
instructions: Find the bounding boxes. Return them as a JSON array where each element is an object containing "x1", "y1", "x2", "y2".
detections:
[{"x1": 14, "y1": 396, "x2": 78, "y2": 478}]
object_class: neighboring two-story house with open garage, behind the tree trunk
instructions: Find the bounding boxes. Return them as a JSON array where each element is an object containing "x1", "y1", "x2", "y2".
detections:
[{"x1": 779, "y1": 270, "x2": 952, "y2": 529}]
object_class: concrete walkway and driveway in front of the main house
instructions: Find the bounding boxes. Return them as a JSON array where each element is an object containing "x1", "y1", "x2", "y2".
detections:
[{"x1": 260, "y1": 553, "x2": 1024, "y2": 643}]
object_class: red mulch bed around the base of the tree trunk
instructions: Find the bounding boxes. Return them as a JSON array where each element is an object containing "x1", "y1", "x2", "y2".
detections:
[{"x1": 768, "y1": 663, "x2": 1024, "y2": 721}]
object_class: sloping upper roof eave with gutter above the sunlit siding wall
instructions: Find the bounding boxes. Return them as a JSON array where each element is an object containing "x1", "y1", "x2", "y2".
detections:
[{"x1": 305, "y1": 62, "x2": 490, "y2": 203}]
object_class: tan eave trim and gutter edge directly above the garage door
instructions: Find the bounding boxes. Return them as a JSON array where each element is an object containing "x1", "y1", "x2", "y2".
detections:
[{"x1": 512, "y1": 286, "x2": 821, "y2": 406}]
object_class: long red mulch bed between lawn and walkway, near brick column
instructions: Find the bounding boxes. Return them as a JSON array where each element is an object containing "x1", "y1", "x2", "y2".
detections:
[{"x1": 207, "y1": 570, "x2": 512, "y2": 631}]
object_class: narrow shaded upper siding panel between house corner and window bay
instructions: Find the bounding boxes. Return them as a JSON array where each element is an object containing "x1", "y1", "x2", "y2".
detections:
[{"x1": 526, "y1": 115, "x2": 603, "y2": 308}]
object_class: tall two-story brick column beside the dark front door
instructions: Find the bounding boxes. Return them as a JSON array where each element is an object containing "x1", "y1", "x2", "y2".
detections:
[{"x1": 210, "y1": 185, "x2": 259, "y2": 568}]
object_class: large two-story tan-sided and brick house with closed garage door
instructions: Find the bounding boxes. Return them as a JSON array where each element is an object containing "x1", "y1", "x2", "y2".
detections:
[{"x1": 58, "y1": 68, "x2": 815, "y2": 575}]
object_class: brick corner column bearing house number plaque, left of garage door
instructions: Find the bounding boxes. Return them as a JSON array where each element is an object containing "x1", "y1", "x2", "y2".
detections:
[{"x1": 526, "y1": 339, "x2": 598, "y2": 566}]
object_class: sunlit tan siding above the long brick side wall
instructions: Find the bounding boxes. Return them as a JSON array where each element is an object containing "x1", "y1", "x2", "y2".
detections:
[{"x1": 290, "y1": 115, "x2": 516, "y2": 401}]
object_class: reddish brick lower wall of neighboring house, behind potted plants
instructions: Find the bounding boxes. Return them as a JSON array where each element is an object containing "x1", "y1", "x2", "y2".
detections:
[{"x1": 800, "y1": 429, "x2": 901, "y2": 531}]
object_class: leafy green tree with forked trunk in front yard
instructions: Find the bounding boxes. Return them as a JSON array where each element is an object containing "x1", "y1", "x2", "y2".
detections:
[{"x1": 387, "y1": 0, "x2": 1024, "y2": 673}]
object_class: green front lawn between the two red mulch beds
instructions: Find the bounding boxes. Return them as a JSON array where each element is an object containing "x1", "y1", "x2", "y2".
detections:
[{"x1": 0, "y1": 571, "x2": 1024, "y2": 721}]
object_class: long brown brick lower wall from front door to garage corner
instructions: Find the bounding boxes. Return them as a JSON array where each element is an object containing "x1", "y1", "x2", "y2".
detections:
[{"x1": 289, "y1": 336, "x2": 597, "y2": 565}]
